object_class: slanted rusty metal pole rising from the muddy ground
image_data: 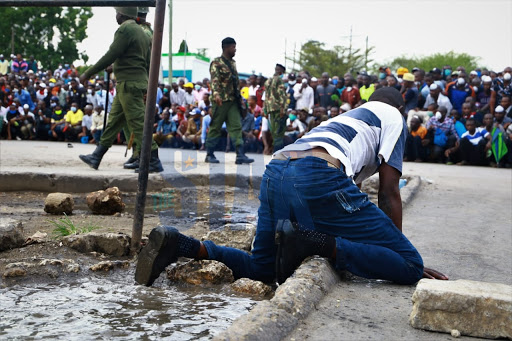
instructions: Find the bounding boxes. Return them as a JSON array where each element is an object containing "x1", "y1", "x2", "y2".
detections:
[{"x1": 131, "y1": 0, "x2": 166, "y2": 254}]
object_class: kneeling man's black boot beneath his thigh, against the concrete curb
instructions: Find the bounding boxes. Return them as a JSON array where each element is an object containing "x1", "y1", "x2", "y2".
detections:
[{"x1": 276, "y1": 220, "x2": 336, "y2": 284}]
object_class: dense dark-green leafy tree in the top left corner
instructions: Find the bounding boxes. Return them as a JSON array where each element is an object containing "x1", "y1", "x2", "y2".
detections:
[{"x1": 0, "y1": 7, "x2": 92, "y2": 69}]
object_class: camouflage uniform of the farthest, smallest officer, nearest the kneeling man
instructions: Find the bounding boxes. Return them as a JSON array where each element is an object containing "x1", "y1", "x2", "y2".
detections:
[{"x1": 265, "y1": 75, "x2": 288, "y2": 152}]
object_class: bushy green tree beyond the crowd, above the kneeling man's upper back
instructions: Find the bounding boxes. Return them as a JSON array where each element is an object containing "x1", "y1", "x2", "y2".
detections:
[{"x1": 287, "y1": 40, "x2": 373, "y2": 77}]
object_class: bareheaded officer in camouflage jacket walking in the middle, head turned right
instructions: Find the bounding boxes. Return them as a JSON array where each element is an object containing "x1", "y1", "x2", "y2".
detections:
[{"x1": 205, "y1": 37, "x2": 254, "y2": 164}]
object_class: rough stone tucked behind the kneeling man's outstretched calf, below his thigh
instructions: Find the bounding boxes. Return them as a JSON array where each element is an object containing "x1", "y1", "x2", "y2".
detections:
[{"x1": 201, "y1": 223, "x2": 256, "y2": 251}]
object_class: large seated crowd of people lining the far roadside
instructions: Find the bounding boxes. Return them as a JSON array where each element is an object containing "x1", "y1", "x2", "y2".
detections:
[{"x1": 0, "y1": 54, "x2": 512, "y2": 167}]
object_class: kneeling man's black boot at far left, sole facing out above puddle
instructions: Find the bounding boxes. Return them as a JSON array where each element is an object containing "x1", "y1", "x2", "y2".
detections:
[{"x1": 135, "y1": 226, "x2": 179, "y2": 286}]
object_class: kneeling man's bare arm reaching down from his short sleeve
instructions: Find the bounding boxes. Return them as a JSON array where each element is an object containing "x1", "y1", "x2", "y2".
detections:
[{"x1": 379, "y1": 162, "x2": 402, "y2": 232}]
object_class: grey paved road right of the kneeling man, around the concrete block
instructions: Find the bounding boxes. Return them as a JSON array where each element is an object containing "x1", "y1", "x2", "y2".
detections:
[{"x1": 286, "y1": 163, "x2": 512, "y2": 340}]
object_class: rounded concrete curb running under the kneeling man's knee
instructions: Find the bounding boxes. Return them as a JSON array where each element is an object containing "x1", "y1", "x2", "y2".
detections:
[{"x1": 214, "y1": 176, "x2": 421, "y2": 341}]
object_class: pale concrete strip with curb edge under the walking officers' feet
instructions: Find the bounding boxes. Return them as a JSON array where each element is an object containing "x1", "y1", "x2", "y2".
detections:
[{"x1": 0, "y1": 141, "x2": 271, "y2": 193}]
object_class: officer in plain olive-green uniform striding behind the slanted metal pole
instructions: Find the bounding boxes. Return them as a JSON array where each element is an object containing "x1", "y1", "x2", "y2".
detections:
[{"x1": 80, "y1": 7, "x2": 163, "y2": 172}]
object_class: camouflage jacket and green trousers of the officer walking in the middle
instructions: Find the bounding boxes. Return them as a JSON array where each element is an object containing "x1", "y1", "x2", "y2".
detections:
[{"x1": 205, "y1": 57, "x2": 243, "y2": 150}]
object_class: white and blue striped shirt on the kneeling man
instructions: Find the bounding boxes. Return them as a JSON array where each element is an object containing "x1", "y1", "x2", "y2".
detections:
[{"x1": 280, "y1": 101, "x2": 407, "y2": 183}]
